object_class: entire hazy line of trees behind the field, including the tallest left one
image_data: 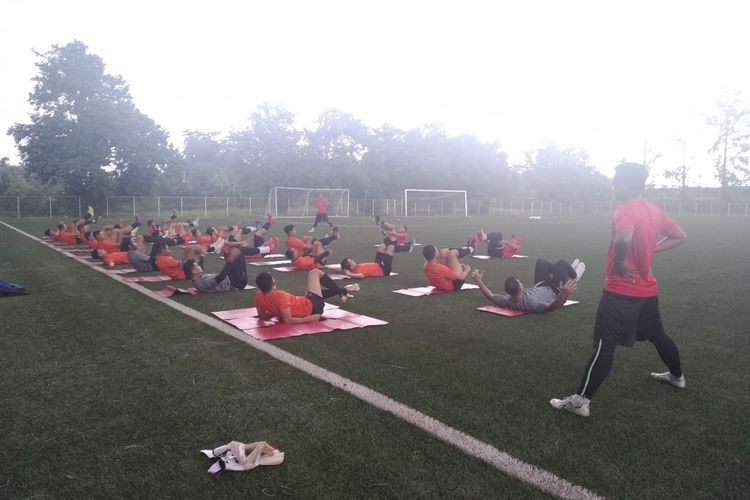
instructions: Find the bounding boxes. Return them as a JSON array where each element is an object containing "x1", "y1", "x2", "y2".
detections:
[{"x1": 0, "y1": 41, "x2": 750, "y2": 200}]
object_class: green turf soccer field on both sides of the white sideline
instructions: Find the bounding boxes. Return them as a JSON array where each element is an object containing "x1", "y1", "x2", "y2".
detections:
[{"x1": 0, "y1": 215, "x2": 750, "y2": 499}]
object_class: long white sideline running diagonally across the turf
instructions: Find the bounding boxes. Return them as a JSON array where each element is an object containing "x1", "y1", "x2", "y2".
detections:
[{"x1": 0, "y1": 221, "x2": 603, "y2": 499}]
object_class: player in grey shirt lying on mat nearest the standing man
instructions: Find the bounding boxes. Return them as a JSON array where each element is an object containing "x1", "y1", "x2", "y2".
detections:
[{"x1": 471, "y1": 259, "x2": 586, "y2": 313}]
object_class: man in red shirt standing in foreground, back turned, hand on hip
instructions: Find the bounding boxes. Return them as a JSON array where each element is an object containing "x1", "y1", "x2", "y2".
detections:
[{"x1": 550, "y1": 163, "x2": 686, "y2": 417}]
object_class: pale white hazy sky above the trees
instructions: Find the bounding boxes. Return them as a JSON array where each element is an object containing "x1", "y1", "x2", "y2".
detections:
[{"x1": 0, "y1": 0, "x2": 750, "y2": 184}]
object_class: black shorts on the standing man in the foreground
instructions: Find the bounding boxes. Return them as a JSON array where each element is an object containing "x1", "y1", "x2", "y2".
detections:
[{"x1": 594, "y1": 292, "x2": 664, "y2": 347}]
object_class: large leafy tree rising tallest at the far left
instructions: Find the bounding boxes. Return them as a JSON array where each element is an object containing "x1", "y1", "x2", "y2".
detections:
[{"x1": 9, "y1": 41, "x2": 178, "y2": 196}]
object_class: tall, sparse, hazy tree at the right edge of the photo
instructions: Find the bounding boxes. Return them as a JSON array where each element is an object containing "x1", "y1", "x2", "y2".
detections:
[{"x1": 707, "y1": 95, "x2": 750, "y2": 200}]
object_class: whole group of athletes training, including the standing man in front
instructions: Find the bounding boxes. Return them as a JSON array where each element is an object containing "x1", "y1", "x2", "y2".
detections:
[{"x1": 45, "y1": 163, "x2": 686, "y2": 416}]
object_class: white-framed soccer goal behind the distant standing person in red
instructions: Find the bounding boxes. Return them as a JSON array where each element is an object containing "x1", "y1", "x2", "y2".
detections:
[{"x1": 267, "y1": 187, "x2": 349, "y2": 217}]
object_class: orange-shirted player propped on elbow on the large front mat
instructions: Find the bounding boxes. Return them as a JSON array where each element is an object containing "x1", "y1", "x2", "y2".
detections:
[{"x1": 255, "y1": 269, "x2": 359, "y2": 323}]
